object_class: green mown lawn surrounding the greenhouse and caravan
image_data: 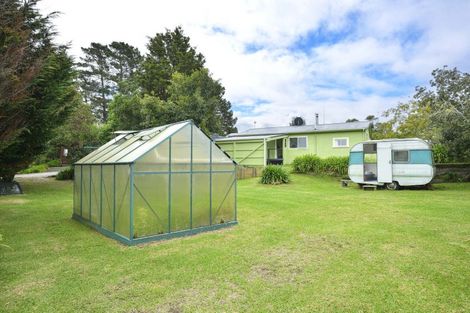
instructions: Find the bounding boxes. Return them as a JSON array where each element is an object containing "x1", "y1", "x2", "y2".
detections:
[{"x1": 0, "y1": 176, "x2": 470, "y2": 312}]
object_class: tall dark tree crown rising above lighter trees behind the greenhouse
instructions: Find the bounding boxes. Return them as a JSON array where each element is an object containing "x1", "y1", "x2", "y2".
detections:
[{"x1": 139, "y1": 27, "x2": 205, "y2": 100}]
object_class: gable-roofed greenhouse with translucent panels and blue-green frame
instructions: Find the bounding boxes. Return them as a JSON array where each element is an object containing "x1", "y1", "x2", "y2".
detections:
[{"x1": 73, "y1": 121, "x2": 237, "y2": 245}]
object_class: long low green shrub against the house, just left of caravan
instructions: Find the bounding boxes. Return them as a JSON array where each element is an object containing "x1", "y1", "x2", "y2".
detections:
[{"x1": 292, "y1": 154, "x2": 349, "y2": 176}]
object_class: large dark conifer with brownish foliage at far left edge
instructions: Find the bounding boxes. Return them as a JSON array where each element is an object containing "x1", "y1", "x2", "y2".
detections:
[{"x1": 0, "y1": 0, "x2": 77, "y2": 181}]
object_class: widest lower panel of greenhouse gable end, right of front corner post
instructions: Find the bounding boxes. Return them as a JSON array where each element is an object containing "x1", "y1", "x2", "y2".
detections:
[{"x1": 134, "y1": 174, "x2": 169, "y2": 238}]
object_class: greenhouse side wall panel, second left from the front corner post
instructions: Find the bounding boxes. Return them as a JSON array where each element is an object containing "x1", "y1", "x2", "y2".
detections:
[{"x1": 101, "y1": 165, "x2": 114, "y2": 231}]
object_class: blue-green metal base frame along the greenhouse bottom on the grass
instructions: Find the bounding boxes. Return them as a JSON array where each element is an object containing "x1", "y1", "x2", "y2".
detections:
[{"x1": 72, "y1": 213, "x2": 238, "y2": 246}]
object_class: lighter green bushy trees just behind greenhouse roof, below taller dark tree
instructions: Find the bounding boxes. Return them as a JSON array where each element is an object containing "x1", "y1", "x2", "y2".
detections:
[{"x1": 110, "y1": 69, "x2": 236, "y2": 134}]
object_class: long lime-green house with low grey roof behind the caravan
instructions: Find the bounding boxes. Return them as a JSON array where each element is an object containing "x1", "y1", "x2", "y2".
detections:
[{"x1": 214, "y1": 118, "x2": 370, "y2": 166}]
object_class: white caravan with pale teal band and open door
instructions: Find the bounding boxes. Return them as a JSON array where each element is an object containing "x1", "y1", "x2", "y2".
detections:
[{"x1": 348, "y1": 138, "x2": 436, "y2": 190}]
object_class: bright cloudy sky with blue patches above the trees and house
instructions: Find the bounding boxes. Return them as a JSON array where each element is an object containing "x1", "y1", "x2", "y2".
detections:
[{"x1": 39, "y1": 0, "x2": 470, "y2": 130}]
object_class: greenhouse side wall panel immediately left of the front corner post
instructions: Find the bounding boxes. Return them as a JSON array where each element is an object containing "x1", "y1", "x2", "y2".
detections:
[{"x1": 115, "y1": 164, "x2": 130, "y2": 238}]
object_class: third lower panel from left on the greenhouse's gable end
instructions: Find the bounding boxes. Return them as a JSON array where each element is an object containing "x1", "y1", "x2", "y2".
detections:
[{"x1": 192, "y1": 173, "x2": 211, "y2": 228}]
